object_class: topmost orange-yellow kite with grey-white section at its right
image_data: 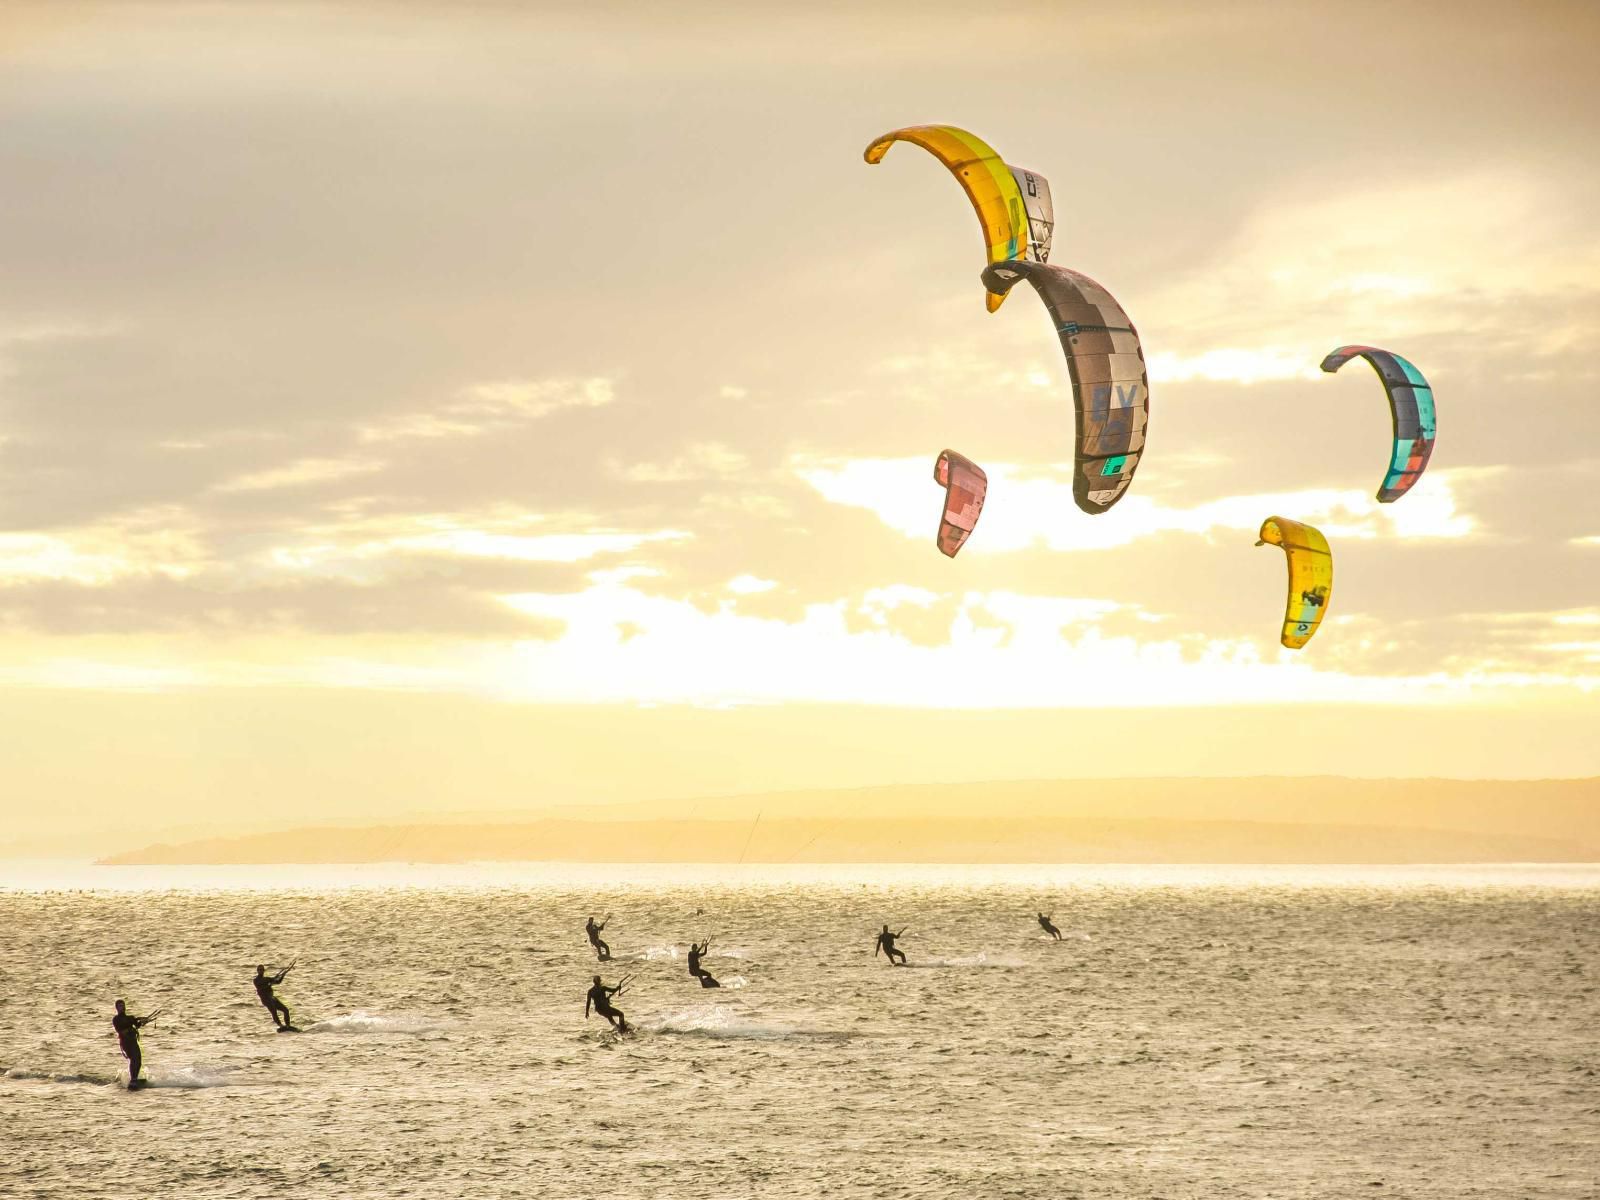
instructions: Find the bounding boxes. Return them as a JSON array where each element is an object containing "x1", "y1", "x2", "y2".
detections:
[{"x1": 866, "y1": 125, "x2": 1056, "y2": 312}]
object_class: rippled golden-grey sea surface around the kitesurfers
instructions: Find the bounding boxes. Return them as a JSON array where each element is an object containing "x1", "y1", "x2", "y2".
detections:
[{"x1": 0, "y1": 862, "x2": 1600, "y2": 1200}]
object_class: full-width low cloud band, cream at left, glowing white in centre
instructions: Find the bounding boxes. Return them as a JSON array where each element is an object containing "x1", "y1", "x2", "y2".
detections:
[{"x1": 0, "y1": 570, "x2": 1600, "y2": 709}]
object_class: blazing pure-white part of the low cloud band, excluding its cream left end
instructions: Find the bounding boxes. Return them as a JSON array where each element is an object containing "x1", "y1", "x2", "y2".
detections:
[{"x1": 480, "y1": 587, "x2": 1600, "y2": 709}]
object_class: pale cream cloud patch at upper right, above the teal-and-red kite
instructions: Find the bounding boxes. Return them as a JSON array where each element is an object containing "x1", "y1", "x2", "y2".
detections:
[{"x1": 1139, "y1": 165, "x2": 1600, "y2": 356}]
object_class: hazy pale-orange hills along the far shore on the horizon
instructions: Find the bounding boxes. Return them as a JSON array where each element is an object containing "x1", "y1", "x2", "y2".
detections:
[{"x1": 101, "y1": 778, "x2": 1600, "y2": 864}]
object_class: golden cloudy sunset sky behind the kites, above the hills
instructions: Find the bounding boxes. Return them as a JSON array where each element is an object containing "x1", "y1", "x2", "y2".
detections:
[{"x1": 0, "y1": 0, "x2": 1600, "y2": 832}]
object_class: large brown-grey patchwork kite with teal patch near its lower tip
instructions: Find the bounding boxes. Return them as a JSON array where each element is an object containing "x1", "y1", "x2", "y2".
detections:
[{"x1": 984, "y1": 262, "x2": 1150, "y2": 515}]
